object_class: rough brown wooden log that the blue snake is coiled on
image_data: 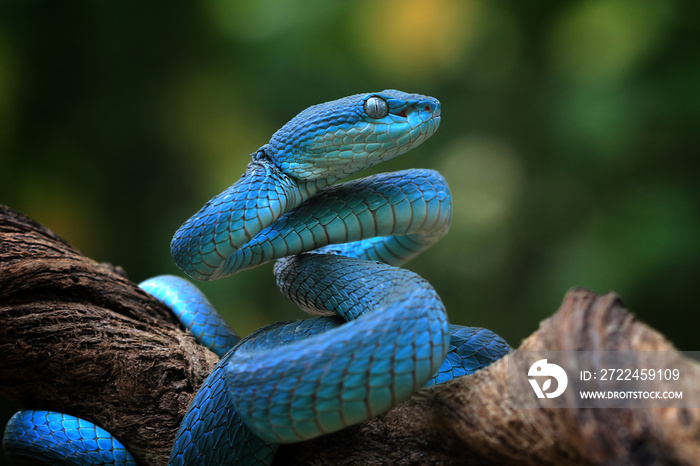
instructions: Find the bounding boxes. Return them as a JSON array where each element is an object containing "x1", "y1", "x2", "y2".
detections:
[{"x1": 0, "y1": 207, "x2": 700, "y2": 465}]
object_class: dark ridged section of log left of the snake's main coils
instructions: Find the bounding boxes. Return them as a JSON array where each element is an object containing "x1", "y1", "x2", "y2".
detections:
[{"x1": 0, "y1": 207, "x2": 217, "y2": 464}]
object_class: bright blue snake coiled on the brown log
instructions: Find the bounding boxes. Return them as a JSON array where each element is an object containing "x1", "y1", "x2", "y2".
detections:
[{"x1": 4, "y1": 90, "x2": 510, "y2": 465}]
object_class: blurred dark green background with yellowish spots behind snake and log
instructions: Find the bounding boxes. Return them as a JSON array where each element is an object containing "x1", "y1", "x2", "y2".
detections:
[{"x1": 0, "y1": 0, "x2": 700, "y2": 458}]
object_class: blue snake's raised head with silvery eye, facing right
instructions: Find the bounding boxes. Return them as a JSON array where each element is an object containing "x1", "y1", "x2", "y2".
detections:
[{"x1": 266, "y1": 90, "x2": 440, "y2": 181}]
